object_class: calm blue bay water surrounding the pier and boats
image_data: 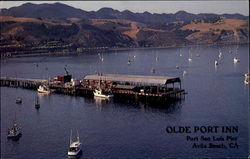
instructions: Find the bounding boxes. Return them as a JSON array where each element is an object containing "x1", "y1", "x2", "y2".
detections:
[{"x1": 1, "y1": 46, "x2": 249, "y2": 159}]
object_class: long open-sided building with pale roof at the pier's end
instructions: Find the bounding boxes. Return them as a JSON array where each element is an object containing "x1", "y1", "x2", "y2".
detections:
[{"x1": 83, "y1": 74, "x2": 184, "y2": 98}]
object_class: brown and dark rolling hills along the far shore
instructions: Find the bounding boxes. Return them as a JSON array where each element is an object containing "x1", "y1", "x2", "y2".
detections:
[{"x1": 0, "y1": 3, "x2": 249, "y2": 56}]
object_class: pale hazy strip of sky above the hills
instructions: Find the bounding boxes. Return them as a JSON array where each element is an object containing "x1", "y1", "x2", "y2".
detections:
[{"x1": 0, "y1": 0, "x2": 249, "y2": 15}]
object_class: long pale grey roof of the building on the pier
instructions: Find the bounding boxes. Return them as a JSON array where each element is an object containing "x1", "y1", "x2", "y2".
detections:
[{"x1": 84, "y1": 74, "x2": 180, "y2": 85}]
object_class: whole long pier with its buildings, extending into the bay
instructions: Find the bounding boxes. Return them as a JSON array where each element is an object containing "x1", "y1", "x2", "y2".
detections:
[{"x1": 0, "y1": 74, "x2": 185, "y2": 102}]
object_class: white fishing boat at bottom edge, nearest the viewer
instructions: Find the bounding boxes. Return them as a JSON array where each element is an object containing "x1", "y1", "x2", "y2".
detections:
[{"x1": 68, "y1": 130, "x2": 82, "y2": 156}]
